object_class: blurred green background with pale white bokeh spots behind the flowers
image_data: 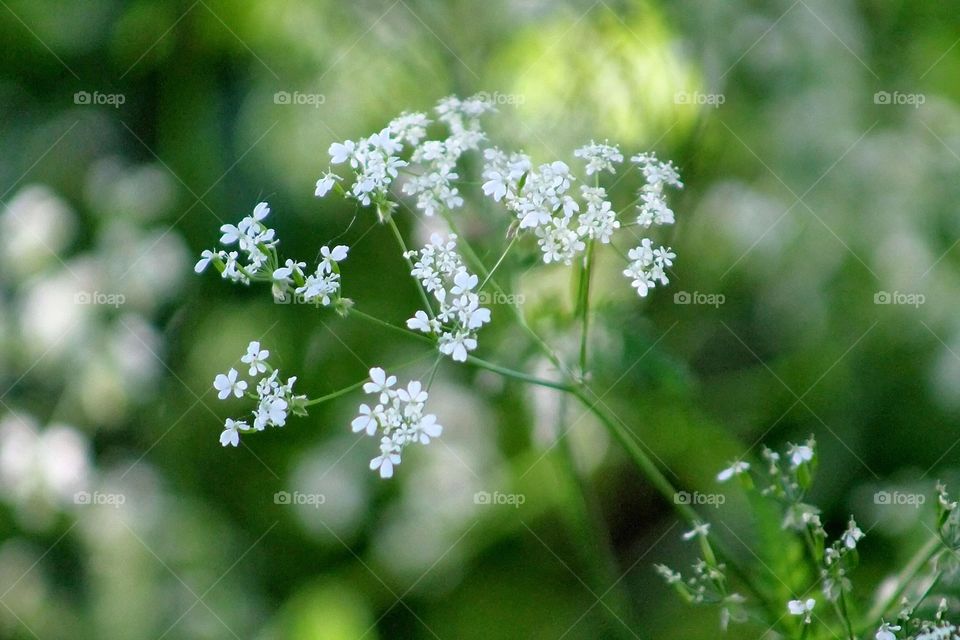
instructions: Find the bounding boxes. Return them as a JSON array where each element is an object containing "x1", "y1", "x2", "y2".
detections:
[{"x1": 0, "y1": 0, "x2": 960, "y2": 640}]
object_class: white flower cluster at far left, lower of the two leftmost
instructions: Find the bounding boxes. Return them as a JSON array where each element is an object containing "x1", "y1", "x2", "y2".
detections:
[{"x1": 213, "y1": 341, "x2": 306, "y2": 447}]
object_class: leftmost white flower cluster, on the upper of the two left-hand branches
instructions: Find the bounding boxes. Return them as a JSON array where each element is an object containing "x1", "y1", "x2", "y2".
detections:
[{"x1": 194, "y1": 202, "x2": 277, "y2": 284}]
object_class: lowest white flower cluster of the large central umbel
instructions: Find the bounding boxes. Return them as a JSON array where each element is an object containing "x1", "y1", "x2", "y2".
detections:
[{"x1": 351, "y1": 367, "x2": 443, "y2": 478}]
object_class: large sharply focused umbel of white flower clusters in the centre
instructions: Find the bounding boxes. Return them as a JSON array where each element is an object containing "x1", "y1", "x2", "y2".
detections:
[{"x1": 195, "y1": 96, "x2": 683, "y2": 477}]
